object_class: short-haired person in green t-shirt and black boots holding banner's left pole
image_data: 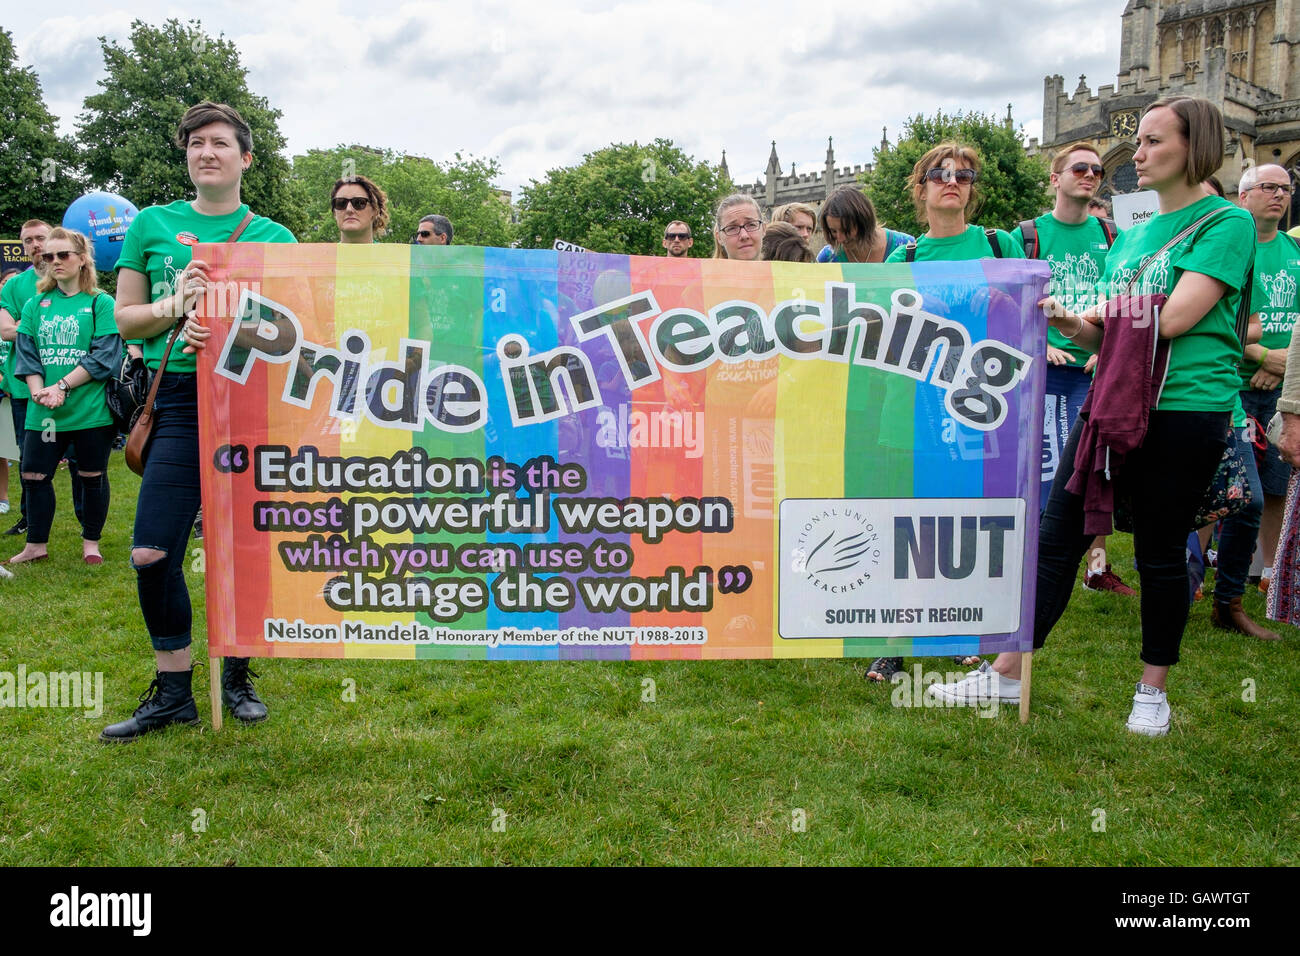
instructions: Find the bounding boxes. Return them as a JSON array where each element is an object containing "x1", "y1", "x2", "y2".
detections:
[{"x1": 100, "y1": 101, "x2": 295, "y2": 741}]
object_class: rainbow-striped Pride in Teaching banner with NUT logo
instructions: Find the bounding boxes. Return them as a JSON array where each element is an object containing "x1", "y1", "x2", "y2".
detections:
[{"x1": 195, "y1": 243, "x2": 1048, "y2": 659}]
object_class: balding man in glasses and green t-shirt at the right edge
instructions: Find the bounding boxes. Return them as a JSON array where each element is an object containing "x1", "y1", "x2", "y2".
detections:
[{"x1": 1210, "y1": 164, "x2": 1300, "y2": 629}]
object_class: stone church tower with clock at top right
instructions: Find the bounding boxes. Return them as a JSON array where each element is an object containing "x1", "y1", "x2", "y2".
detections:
[{"x1": 1030, "y1": 0, "x2": 1300, "y2": 222}]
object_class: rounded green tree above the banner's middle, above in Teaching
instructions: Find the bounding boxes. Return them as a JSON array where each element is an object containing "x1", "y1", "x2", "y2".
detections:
[{"x1": 519, "y1": 139, "x2": 731, "y2": 256}]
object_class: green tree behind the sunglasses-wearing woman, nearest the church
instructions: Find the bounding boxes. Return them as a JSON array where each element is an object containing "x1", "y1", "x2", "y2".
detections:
[{"x1": 863, "y1": 113, "x2": 1049, "y2": 235}]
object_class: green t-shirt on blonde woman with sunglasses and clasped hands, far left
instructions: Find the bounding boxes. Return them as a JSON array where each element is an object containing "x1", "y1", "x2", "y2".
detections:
[{"x1": 18, "y1": 287, "x2": 117, "y2": 432}]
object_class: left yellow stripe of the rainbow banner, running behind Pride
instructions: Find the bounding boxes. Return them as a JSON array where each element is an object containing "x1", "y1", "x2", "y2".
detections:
[{"x1": 334, "y1": 243, "x2": 413, "y2": 659}]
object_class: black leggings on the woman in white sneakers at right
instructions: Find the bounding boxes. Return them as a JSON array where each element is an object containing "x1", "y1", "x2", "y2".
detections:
[{"x1": 1034, "y1": 411, "x2": 1231, "y2": 667}]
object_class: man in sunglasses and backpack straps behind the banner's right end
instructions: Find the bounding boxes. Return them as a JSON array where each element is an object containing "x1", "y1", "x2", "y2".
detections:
[{"x1": 1011, "y1": 143, "x2": 1136, "y2": 594}]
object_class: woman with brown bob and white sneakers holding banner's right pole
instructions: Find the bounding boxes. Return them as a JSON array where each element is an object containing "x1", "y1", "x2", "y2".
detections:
[{"x1": 931, "y1": 96, "x2": 1255, "y2": 736}]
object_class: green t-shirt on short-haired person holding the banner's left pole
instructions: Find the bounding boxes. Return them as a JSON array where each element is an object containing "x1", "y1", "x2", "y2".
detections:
[{"x1": 117, "y1": 199, "x2": 298, "y2": 372}]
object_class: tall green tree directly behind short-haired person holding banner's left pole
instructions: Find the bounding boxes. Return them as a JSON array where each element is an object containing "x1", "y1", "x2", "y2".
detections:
[{"x1": 78, "y1": 20, "x2": 307, "y2": 235}]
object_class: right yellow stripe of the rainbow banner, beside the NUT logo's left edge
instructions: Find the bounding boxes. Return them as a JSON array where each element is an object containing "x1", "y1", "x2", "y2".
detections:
[{"x1": 772, "y1": 263, "x2": 849, "y2": 657}]
